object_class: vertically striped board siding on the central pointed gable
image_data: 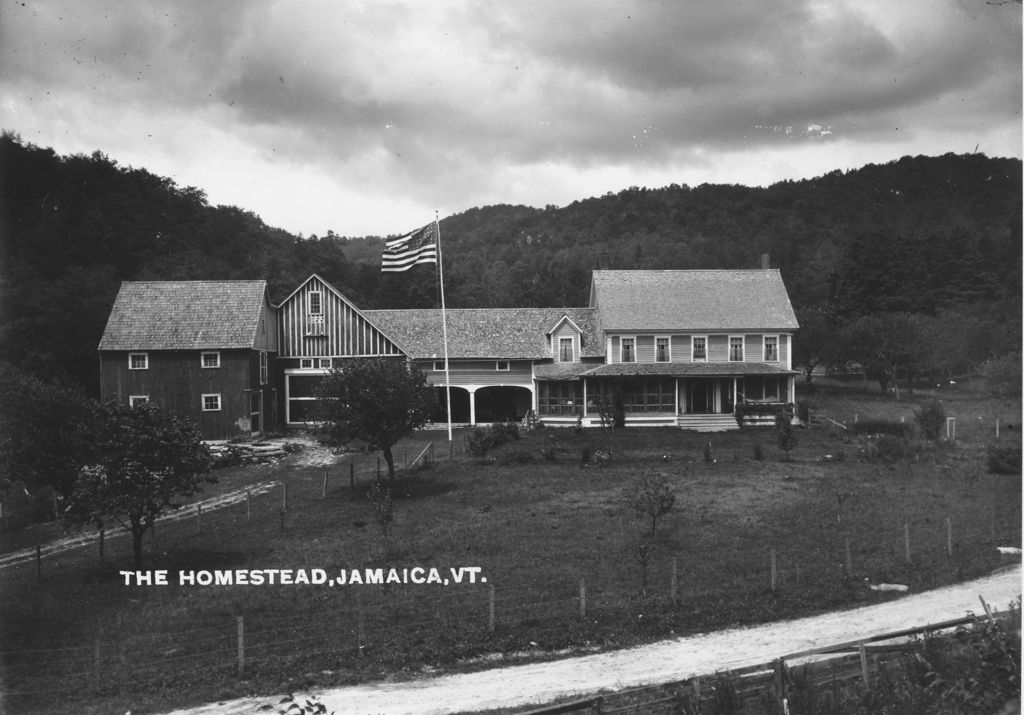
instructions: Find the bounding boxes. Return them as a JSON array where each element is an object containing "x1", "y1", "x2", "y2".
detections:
[{"x1": 278, "y1": 277, "x2": 402, "y2": 358}]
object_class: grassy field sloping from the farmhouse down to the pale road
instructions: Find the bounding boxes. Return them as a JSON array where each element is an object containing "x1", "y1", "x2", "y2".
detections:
[{"x1": 0, "y1": 384, "x2": 1021, "y2": 713}]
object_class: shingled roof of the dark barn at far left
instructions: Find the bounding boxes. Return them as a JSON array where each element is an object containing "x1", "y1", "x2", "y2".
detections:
[{"x1": 99, "y1": 281, "x2": 266, "y2": 350}]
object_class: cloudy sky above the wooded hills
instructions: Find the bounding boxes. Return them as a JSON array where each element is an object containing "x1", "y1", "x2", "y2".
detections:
[{"x1": 0, "y1": 0, "x2": 1022, "y2": 236}]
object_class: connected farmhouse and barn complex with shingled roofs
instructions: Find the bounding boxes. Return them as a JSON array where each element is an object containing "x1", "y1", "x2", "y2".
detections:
[{"x1": 99, "y1": 268, "x2": 798, "y2": 438}]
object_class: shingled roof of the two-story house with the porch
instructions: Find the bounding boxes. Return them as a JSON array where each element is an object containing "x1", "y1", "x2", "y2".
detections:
[{"x1": 590, "y1": 268, "x2": 799, "y2": 332}]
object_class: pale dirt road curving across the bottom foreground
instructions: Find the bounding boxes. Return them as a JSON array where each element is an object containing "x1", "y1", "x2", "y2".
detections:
[{"x1": 163, "y1": 564, "x2": 1021, "y2": 715}]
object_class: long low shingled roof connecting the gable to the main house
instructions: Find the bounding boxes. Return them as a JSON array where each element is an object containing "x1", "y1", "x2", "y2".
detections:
[{"x1": 361, "y1": 308, "x2": 604, "y2": 360}]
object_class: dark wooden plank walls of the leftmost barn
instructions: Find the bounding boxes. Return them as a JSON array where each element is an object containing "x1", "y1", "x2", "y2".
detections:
[{"x1": 99, "y1": 350, "x2": 258, "y2": 439}]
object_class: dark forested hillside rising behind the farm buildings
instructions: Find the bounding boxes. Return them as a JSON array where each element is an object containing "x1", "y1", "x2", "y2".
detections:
[{"x1": 0, "y1": 134, "x2": 1022, "y2": 392}]
